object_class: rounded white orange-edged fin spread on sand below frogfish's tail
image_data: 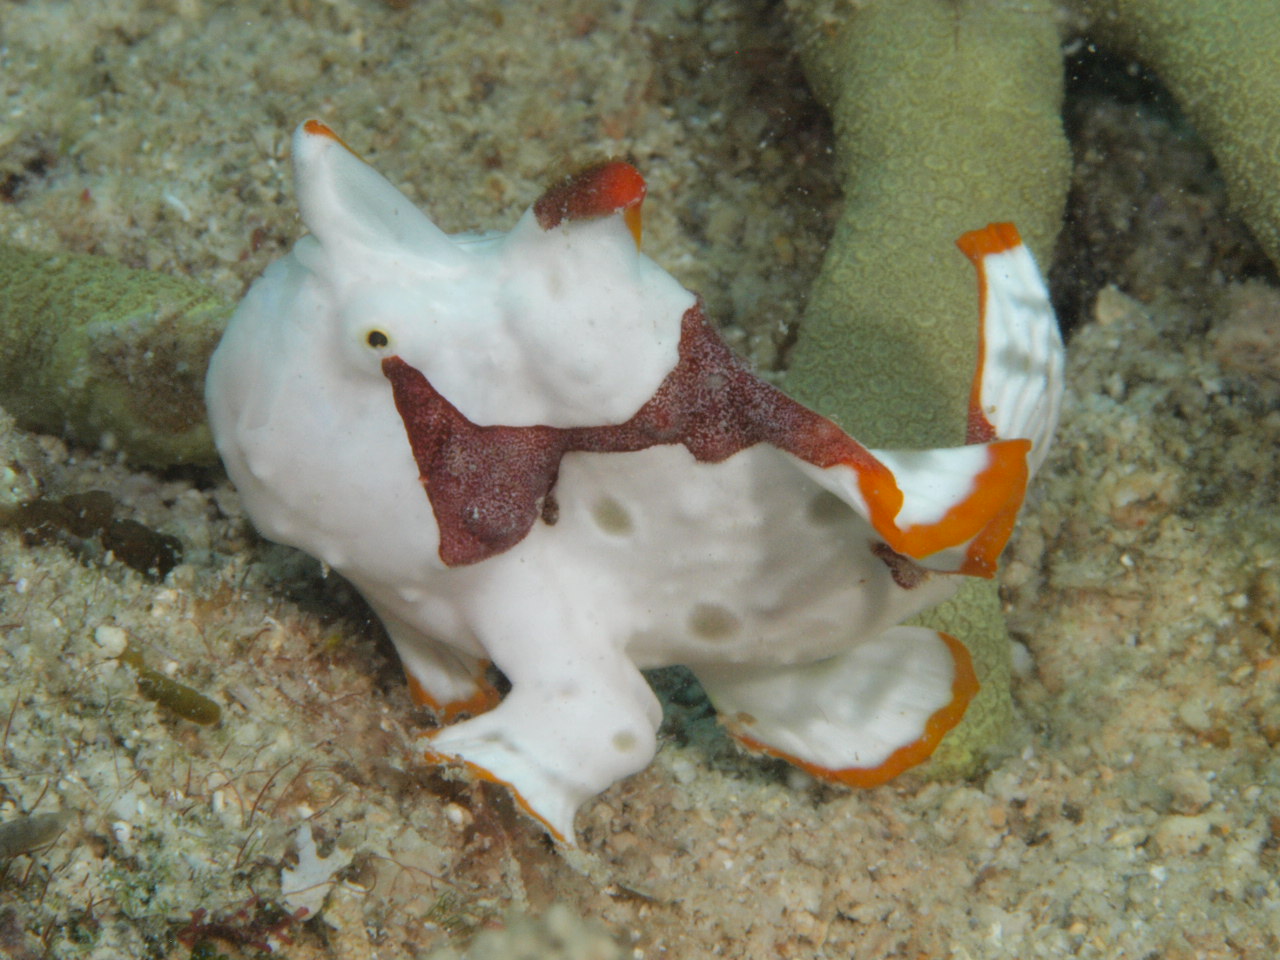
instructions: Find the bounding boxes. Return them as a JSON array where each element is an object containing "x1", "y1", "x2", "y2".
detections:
[{"x1": 695, "y1": 627, "x2": 978, "y2": 787}]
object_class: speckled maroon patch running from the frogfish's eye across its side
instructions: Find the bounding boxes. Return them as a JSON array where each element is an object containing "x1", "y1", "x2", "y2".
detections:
[{"x1": 383, "y1": 303, "x2": 887, "y2": 567}]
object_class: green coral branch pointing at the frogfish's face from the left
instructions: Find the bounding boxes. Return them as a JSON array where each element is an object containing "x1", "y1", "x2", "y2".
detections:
[{"x1": 0, "y1": 244, "x2": 225, "y2": 467}]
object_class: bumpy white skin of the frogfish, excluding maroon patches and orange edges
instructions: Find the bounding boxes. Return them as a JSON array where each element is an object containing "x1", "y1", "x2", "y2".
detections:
[{"x1": 207, "y1": 125, "x2": 1061, "y2": 842}]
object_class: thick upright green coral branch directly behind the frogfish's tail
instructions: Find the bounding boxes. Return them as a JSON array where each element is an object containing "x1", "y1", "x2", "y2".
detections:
[{"x1": 786, "y1": 0, "x2": 1070, "y2": 774}]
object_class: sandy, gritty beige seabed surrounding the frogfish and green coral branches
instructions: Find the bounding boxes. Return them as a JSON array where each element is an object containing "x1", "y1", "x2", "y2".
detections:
[{"x1": 0, "y1": 0, "x2": 1280, "y2": 960}]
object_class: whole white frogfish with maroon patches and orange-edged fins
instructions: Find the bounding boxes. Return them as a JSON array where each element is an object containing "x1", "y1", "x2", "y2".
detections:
[{"x1": 206, "y1": 120, "x2": 1062, "y2": 844}]
